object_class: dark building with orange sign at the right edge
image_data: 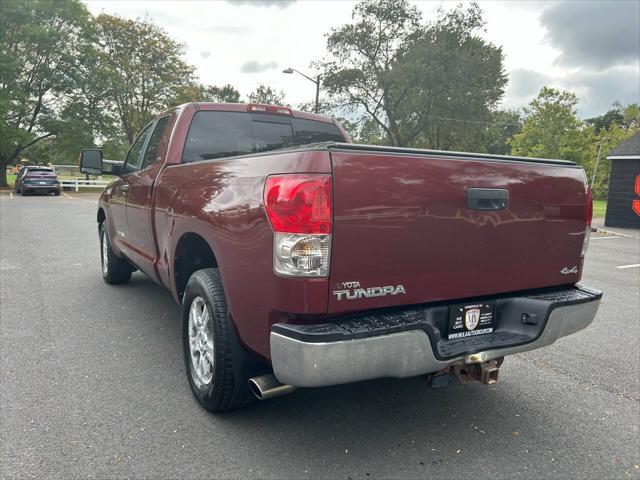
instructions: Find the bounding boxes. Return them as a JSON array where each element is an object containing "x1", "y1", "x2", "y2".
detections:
[{"x1": 604, "y1": 132, "x2": 640, "y2": 228}]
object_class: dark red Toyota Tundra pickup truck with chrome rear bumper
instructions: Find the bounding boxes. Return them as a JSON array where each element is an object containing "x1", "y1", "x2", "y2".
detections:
[{"x1": 80, "y1": 103, "x2": 602, "y2": 411}]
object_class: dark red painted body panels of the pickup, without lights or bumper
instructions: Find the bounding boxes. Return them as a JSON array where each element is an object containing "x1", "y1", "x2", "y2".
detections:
[{"x1": 100, "y1": 104, "x2": 586, "y2": 358}]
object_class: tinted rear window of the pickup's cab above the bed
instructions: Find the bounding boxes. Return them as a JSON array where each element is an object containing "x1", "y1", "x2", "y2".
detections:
[{"x1": 182, "y1": 111, "x2": 345, "y2": 163}]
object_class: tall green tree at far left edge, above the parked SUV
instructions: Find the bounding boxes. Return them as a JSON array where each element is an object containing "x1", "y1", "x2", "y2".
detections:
[{"x1": 0, "y1": 0, "x2": 89, "y2": 186}]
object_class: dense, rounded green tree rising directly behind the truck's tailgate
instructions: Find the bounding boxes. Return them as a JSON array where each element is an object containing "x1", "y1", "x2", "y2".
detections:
[{"x1": 395, "y1": 4, "x2": 507, "y2": 151}]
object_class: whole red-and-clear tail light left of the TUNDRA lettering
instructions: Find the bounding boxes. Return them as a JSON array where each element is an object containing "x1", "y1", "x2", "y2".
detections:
[{"x1": 264, "y1": 174, "x2": 332, "y2": 277}]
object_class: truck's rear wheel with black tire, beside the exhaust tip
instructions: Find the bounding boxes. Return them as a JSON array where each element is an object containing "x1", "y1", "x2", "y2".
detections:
[{"x1": 181, "y1": 268, "x2": 260, "y2": 412}]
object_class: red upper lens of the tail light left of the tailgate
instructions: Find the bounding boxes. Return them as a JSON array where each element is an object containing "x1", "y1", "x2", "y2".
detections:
[{"x1": 264, "y1": 174, "x2": 332, "y2": 234}]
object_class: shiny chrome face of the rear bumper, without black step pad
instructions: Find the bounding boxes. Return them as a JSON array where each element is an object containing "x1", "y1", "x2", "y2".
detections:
[{"x1": 270, "y1": 294, "x2": 601, "y2": 387}]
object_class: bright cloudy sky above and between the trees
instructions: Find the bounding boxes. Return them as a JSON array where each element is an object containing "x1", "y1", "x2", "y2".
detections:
[{"x1": 87, "y1": 0, "x2": 640, "y2": 117}]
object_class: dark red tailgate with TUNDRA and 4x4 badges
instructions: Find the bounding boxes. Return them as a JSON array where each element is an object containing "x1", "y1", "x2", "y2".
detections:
[{"x1": 329, "y1": 149, "x2": 587, "y2": 313}]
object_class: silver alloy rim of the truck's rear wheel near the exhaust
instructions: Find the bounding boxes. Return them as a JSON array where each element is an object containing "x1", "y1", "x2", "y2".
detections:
[{"x1": 189, "y1": 297, "x2": 214, "y2": 388}]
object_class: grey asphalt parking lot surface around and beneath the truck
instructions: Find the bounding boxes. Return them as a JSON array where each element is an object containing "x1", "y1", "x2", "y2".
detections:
[{"x1": 0, "y1": 194, "x2": 640, "y2": 479}]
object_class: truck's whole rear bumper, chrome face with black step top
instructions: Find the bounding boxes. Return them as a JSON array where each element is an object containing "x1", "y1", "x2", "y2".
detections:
[{"x1": 270, "y1": 286, "x2": 602, "y2": 387}]
